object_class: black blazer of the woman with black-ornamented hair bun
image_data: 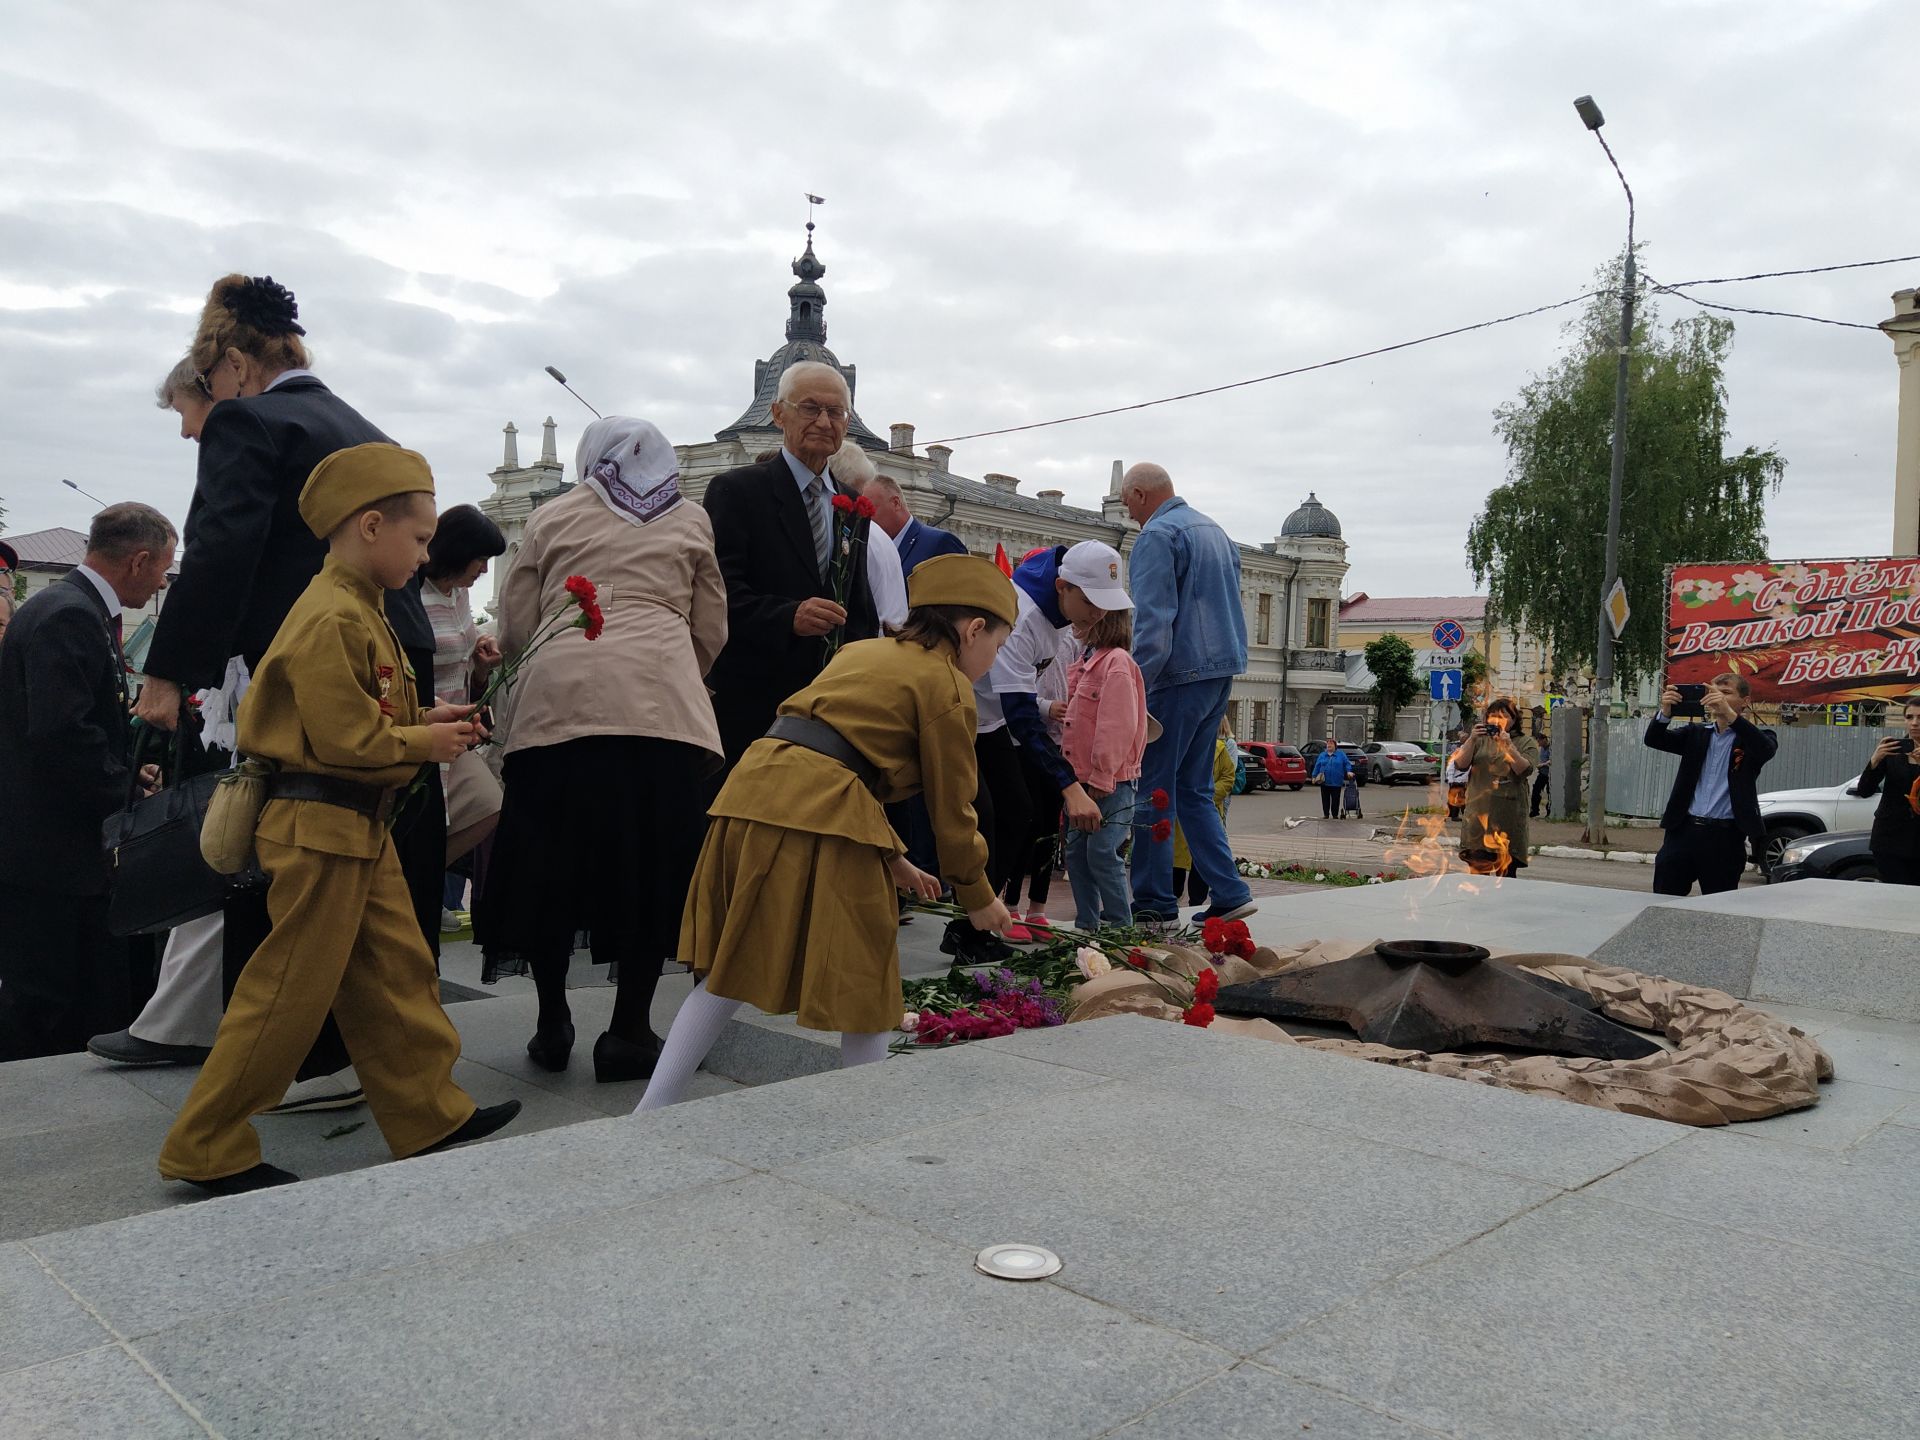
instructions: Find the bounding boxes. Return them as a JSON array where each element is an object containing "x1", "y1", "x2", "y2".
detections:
[{"x1": 146, "y1": 376, "x2": 393, "y2": 691}]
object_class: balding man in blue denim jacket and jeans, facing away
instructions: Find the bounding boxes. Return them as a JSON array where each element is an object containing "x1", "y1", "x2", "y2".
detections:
[{"x1": 1119, "y1": 465, "x2": 1254, "y2": 922}]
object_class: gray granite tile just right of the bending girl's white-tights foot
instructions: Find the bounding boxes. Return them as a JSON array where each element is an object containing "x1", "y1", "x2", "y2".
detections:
[{"x1": 634, "y1": 1044, "x2": 1102, "y2": 1169}]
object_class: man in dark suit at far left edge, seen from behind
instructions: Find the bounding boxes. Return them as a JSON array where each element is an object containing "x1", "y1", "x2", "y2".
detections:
[{"x1": 0, "y1": 503, "x2": 177, "y2": 1060}]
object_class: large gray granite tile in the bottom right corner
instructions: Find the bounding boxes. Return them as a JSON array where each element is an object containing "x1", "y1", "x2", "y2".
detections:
[{"x1": 1261, "y1": 1196, "x2": 1920, "y2": 1440}]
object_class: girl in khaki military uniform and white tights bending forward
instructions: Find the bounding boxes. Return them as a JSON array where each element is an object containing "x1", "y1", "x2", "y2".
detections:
[{"x1": 637, "y1": 555, "x2": 1016, "y2": 1110}]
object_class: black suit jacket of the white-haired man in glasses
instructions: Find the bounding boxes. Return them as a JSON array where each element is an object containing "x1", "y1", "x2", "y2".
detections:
[{"x1": 705, "y1": 453, "x2": 879, "y2": 764}]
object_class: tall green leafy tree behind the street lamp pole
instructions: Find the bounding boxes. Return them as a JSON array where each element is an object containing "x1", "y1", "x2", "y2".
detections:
[{"x1": 1467, "y1": 263, "x2": 1786, "y2": 684}]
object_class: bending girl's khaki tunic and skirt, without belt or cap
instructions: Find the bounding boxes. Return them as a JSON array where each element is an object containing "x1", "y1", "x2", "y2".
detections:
[{"x1": 680, "y1": 639, "x2": 993, "y2": 1035}]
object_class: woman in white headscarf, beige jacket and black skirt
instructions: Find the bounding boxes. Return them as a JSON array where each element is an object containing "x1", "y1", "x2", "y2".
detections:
[{"x1": 476, "y1": 415, "x2": 726, "y2": 1081}]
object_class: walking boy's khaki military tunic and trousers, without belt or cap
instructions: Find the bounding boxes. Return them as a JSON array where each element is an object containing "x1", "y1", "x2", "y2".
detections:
[{"x1": 159, "y1": 557, "x2": 474, "y2": 1179}]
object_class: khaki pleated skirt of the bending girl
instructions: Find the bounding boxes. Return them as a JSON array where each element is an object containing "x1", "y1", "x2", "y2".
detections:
[{"x1": 680, "y1": 816, "x2": 902, "y2": 1035}]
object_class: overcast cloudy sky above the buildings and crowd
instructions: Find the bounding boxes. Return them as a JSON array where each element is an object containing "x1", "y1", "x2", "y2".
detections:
[{"x1": 0, "y1": 0, "x2": 1920, "y2": 595}]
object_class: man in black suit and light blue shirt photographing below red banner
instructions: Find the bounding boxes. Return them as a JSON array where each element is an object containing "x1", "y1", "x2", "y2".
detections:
[{"x1": 1645, "y1": 674, "x2": 1780, "y2": 895}]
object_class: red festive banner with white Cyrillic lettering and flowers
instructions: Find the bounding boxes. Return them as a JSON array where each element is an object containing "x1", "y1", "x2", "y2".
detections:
[{"x1": 1667, "y1": 559, "x2": 1920, "y2": 705}]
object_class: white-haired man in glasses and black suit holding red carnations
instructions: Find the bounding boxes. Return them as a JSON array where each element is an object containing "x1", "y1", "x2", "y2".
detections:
[{"x1": 705, "y1": 361, "x2": 879, "y2": 768}]
